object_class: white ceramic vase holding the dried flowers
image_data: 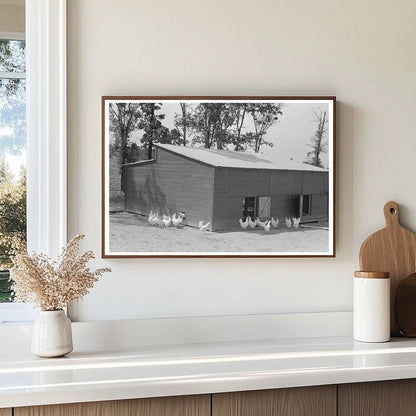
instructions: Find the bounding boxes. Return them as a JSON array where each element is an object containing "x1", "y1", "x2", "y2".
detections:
[{"x1": 31, "y1": 309, "x2": 73, "y2": 358}]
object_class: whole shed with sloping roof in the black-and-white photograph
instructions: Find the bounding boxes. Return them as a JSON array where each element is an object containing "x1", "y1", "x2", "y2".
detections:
[{"x1": 123, "y1": 144, "x2": 329, "y2": 231}]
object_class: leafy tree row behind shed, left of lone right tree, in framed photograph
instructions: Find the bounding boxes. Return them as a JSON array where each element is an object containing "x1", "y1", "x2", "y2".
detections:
[{"x1": 109, "y1": 102, "x2": 284, "y2": 164}]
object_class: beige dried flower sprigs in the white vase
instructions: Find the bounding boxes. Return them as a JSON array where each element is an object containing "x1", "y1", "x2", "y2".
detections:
[{"x1": 10, "y1": 234, "x2": 111, "y2": 311}]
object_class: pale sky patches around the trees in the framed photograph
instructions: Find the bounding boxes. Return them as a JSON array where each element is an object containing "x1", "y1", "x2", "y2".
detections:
[{"x1": 132, "y1": 102, "x2": 329, "y2": 167}]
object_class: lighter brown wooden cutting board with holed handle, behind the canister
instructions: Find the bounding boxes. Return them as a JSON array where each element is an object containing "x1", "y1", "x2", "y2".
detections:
[{"x1": 360, "y1": 201, "x2": 416, "y2": 336}]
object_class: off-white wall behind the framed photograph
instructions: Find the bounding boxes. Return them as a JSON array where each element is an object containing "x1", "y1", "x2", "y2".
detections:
[{"x1": 68, "y1": 0, "x2": 416, "y2": 320}]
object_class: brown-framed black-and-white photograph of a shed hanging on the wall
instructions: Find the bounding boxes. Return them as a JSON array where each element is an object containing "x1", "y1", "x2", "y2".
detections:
[{"x1": 102, "y1": 96, "x2": 336, "y2": 258}]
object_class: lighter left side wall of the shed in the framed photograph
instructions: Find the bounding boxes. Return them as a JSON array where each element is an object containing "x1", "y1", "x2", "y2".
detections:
[{"x1": 126, "y1": 149, "x2": 214, "y2": 226}]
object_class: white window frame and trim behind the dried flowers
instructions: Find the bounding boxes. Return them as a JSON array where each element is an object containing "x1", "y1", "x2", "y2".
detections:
[{"x1": 0, "y1": 0, "x2": 67, "y2": 324}]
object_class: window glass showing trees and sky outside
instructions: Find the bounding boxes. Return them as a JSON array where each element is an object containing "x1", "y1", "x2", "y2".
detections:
[{"x1": 0, "y1": 48, "x2": 26, "y2": 302}]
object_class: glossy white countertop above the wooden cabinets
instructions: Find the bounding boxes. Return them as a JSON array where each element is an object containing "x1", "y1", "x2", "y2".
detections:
[{"x1": 0, "y1": 337, "x2": 416, "y2": 407}]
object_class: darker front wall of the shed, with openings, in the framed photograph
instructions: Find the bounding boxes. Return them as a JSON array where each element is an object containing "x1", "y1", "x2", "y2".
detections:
[{"x1": 213, "y1": 168, "x2": 329, "y2": 231}]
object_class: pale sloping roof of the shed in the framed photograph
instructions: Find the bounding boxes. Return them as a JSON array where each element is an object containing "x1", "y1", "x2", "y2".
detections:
[{"x1": 155, "y1": 143, "x2": 328, "y2": 172}]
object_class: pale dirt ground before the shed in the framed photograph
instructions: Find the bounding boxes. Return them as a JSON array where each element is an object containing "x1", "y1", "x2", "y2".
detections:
[{"x1": 109, "y1": 212, "x2": 328, "y2": 253}]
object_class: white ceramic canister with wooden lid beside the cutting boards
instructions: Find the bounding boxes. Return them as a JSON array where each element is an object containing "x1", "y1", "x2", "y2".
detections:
[{"x1": 353, "y1": 272, "x2": 390, "y2": 342}]
